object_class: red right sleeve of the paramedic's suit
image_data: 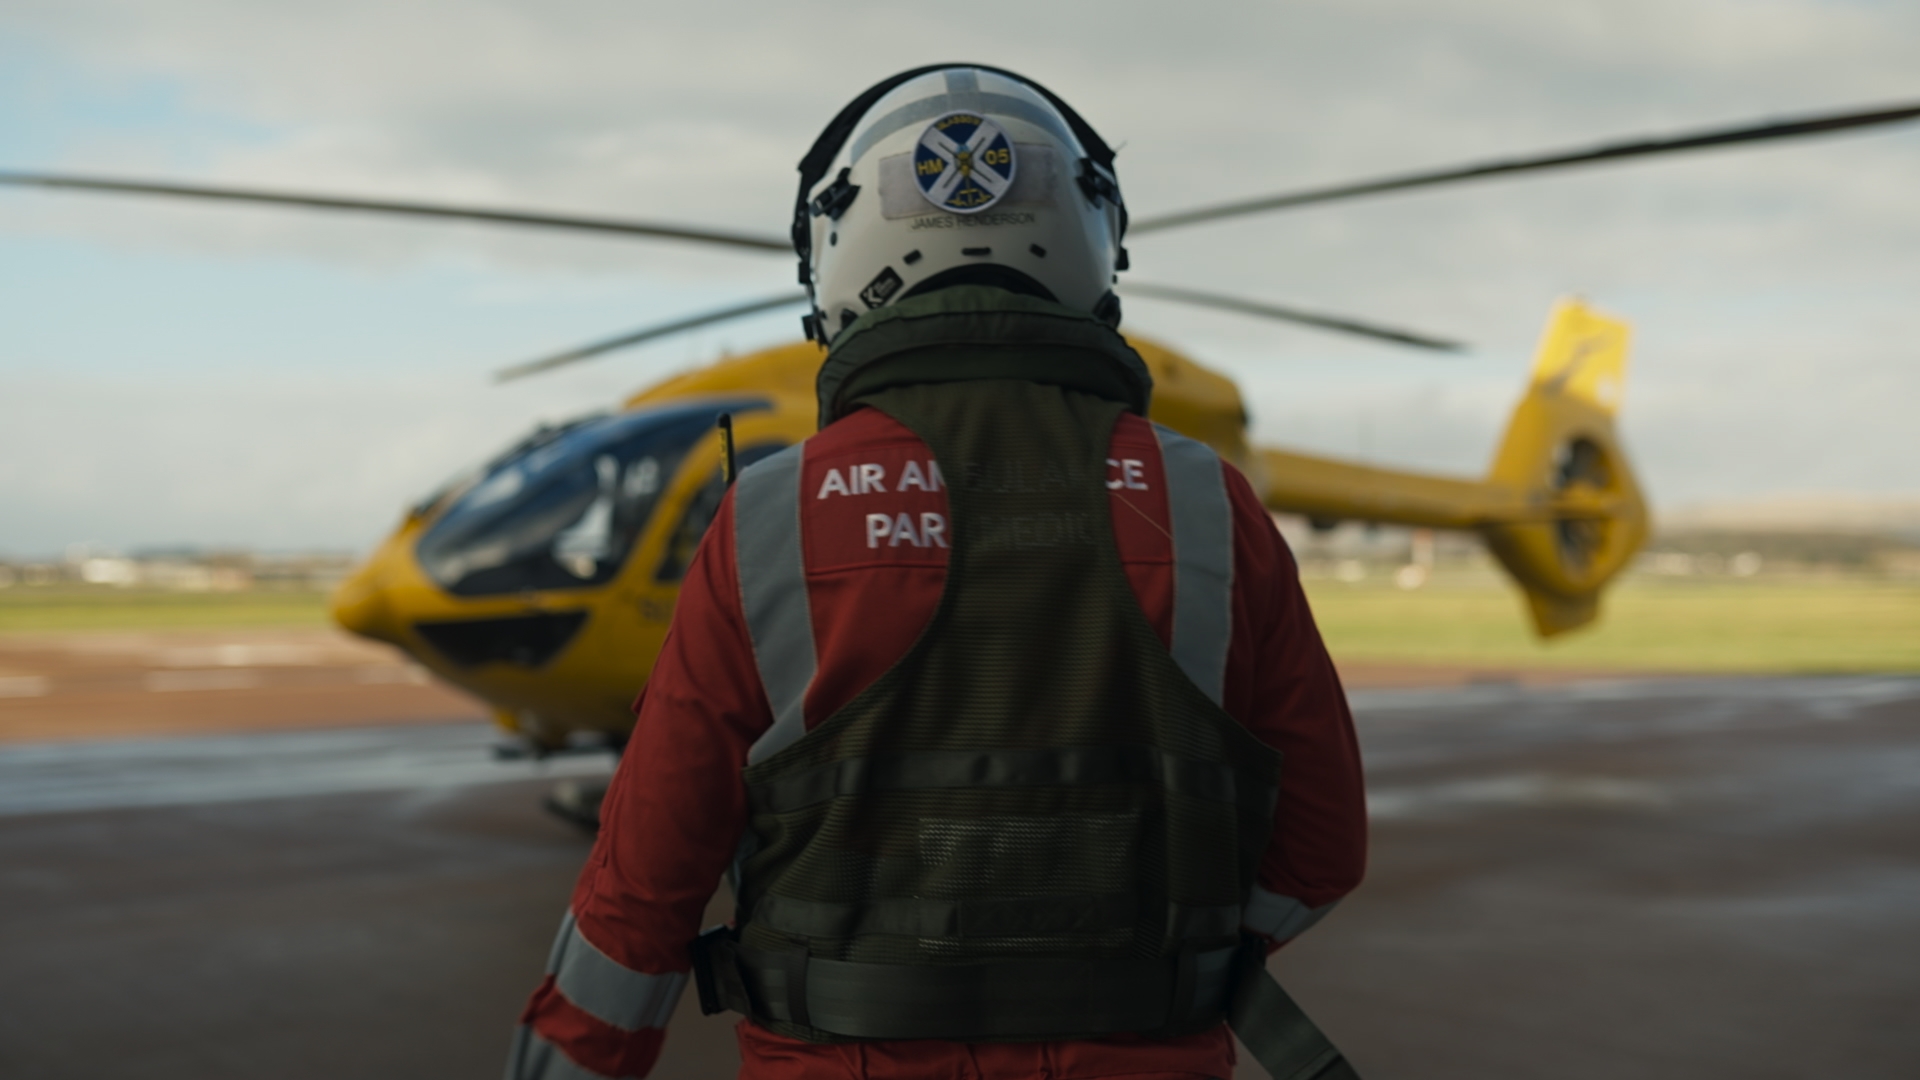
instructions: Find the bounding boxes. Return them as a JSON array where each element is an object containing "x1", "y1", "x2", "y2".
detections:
[{"x1": 1225, "y1": 465, "x2": 1367, "y2": 942}]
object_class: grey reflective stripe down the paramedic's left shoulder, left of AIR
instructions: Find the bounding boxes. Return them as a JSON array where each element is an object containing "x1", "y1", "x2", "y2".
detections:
[{"x1": 733, "y1": 442, "x2": 814, "y2": 765}]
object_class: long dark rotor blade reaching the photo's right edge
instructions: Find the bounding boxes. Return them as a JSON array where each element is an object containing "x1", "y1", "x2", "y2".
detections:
[{"x1": 1127, "y1": 104, "x2": 1920, "y2": 233}]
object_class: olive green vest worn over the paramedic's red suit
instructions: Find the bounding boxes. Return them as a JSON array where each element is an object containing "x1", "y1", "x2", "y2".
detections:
[{"x1": 720, "y1": 372, "x2": 1279, "y2": 1042}]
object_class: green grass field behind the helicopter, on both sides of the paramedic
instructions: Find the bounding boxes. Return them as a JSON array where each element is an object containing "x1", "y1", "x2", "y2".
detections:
[{"x1": 0, "y1": 575, "x2": 1920, "y2": 673}]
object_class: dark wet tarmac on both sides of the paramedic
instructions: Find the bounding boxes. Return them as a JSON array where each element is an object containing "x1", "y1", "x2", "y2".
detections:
[{"x1": 0, "y1": 678, "x2": 1920, "y2": 1080}]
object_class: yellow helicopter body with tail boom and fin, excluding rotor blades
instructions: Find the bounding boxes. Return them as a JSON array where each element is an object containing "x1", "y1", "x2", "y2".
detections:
[{"x1": 332, "y1": 302, "x2": 1645, "y2": 748}]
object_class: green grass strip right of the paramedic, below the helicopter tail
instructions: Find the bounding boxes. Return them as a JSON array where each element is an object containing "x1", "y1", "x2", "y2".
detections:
[{"x1": 1308, "y1": 577, "x2": 1920, "y2": 673}]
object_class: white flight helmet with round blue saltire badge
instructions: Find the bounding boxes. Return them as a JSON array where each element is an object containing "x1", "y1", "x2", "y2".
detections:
[{"x1": 793, "y1": 63, "x2": 1127, "y2": 344}]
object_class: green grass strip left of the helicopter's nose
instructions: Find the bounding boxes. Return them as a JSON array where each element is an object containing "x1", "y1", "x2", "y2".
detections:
[{"x1": 0, "y1": 586, "x2": 328, "y2": 634}]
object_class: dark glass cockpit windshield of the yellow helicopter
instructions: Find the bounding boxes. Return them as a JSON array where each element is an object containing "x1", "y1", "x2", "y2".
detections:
[{"x1": 415, "y1": 398, "x2": 768, "y2": 596}]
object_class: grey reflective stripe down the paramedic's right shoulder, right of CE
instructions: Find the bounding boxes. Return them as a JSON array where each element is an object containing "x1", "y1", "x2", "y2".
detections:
[{"x1": 1154, "y1": 425, "x2": 1233, "y2": 705}]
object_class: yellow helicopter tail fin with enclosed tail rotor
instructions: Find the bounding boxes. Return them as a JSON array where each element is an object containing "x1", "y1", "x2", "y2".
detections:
[{"x1": 1480, "y1": 300, "x2": 1647, "y2": 638}]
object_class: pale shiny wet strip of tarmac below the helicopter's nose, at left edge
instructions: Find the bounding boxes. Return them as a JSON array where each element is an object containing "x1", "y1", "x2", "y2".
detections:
[{"x1": 0, "y1": 724, "x2": 612, "y2": 817}]
